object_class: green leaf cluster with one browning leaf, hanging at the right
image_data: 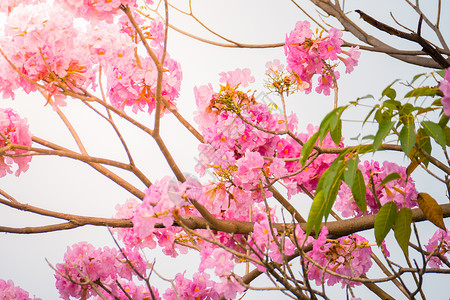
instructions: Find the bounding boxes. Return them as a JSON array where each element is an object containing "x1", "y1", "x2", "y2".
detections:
[{"x1": 300, "y1": 74, "x2": 450, "y2": 256}]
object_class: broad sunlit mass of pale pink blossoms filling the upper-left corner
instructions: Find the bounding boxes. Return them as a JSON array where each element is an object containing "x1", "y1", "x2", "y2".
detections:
[{"x1": 0, "y1": 1, "x2": 182, "y2": 113}]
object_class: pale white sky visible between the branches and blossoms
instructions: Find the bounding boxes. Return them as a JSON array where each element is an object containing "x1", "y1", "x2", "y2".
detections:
[{"x1": 0, "y1": 1, "x2": 450, "y2": 299}]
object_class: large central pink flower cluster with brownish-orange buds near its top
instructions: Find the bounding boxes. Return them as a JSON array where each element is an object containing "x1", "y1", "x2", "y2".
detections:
[{"x1": 194, "y1": 70, "x2": 343, "y2": 214}]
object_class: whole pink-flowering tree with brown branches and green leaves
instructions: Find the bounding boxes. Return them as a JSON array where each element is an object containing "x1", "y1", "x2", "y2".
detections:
[{"x1": 0, "y1": 0, "x2": 450, "y2": 299}]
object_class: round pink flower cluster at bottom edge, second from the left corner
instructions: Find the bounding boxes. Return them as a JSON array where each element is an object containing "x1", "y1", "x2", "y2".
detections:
[{"x1": 55, "y1": 242, "x2": 149, "y2": 300}]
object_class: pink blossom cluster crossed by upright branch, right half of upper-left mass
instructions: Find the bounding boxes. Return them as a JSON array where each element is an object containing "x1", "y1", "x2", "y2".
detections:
[{"x1": 87, "y1": 14, "x2": 182, "y2": 113}]
